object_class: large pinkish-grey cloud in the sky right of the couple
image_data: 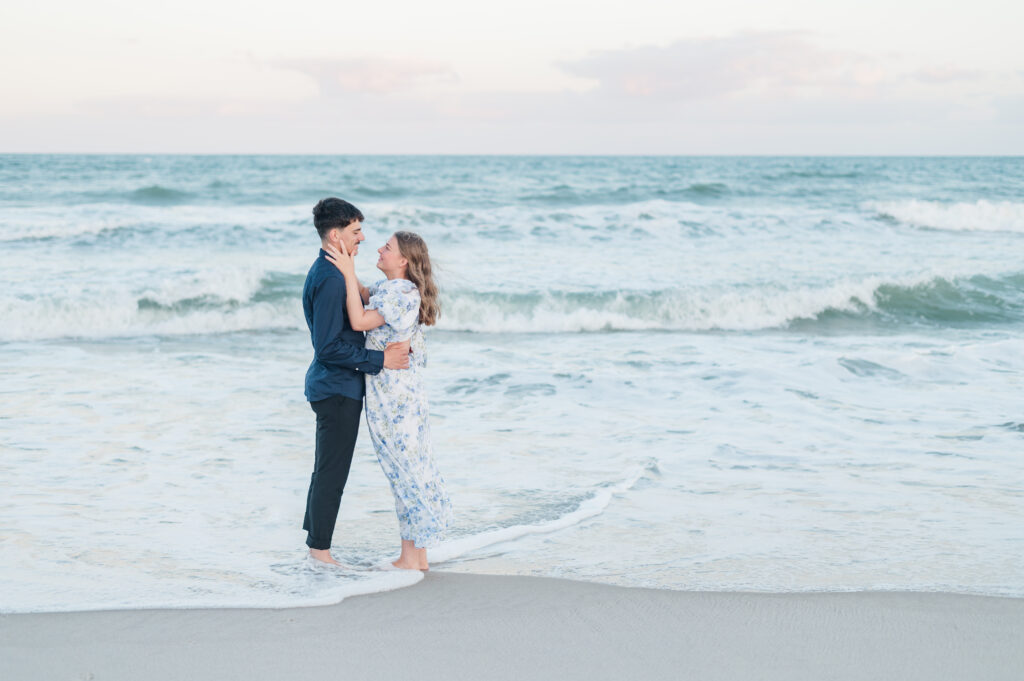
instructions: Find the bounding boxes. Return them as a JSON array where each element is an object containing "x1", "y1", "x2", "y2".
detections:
[{"x1": 559, "y1": 32, "x2": 868, "y2": 99}]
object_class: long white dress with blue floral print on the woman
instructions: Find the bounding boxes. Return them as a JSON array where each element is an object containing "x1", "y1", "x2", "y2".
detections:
[{"x1": 366, "y1": 279, "x2": 452, "y2": 548}]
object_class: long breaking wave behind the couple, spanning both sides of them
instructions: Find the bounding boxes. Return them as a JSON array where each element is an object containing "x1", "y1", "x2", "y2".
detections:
[{"x1": 0, "y1": 267, "x2": 1024, "y2": 341}]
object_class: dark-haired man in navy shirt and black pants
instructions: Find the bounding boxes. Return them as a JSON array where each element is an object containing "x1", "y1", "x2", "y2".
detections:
[{"x1": 302, "y1": 198, "x2": 409, "y2": 565}]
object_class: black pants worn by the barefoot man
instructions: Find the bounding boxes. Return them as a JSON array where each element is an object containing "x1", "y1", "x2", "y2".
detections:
[{"x1": 302, "y1": 395, "x2": 362, "y2": 549}]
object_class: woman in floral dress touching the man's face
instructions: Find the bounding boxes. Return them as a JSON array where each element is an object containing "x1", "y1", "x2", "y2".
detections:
[{"x1": 327, "y1": 231, "x2": 452, "y2": 570}]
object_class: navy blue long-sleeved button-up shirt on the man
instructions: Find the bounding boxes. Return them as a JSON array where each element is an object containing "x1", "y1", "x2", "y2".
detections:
[{"x1": 302, "y1": 249, "x2": 384, "y2": 402}]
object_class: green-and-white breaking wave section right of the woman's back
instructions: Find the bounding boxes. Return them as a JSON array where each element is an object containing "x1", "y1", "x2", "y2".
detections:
[{"x1": 438, "y1": 274, "x2": 1024, "y2": 333}]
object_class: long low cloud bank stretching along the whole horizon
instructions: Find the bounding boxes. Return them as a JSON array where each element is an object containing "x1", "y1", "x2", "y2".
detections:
[{"x1": 9, "y1": 32, "x2": 1024, "y2": 155}]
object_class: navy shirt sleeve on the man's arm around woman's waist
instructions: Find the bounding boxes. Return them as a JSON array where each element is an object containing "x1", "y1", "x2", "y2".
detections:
[{"x1": 310, "y1": 276, "x2": 384, "y2": 374}]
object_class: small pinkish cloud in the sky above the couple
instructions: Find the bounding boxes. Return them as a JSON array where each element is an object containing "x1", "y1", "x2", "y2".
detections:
[{"x1": 274, "y1": 58, "x2": 458, "y2": 97}]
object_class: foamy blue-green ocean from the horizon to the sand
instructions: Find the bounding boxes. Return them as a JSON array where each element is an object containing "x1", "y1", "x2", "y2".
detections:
[{"x1": 0, "y1": 156, "x2": 1024, "y2": 612}]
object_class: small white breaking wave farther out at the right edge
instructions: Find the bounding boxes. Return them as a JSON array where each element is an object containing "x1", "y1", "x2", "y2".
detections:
[{"x1": 868, "y1": 199, "x2": 1024, "y2": 232}]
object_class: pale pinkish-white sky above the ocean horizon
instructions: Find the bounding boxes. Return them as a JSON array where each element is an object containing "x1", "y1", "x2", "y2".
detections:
[{"x1": 0, "y1": 0, "x2": 1024, "y2": 155}]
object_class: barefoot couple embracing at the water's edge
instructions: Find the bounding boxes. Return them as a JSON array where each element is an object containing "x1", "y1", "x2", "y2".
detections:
[{"x1": 302, "y1": 198, "x2": 452, "y2": 569}]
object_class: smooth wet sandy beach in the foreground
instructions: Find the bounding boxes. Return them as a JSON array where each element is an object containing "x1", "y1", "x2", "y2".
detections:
[{"x1": 0, "y1": 572, "x2": 1024, "y2": 681}]
